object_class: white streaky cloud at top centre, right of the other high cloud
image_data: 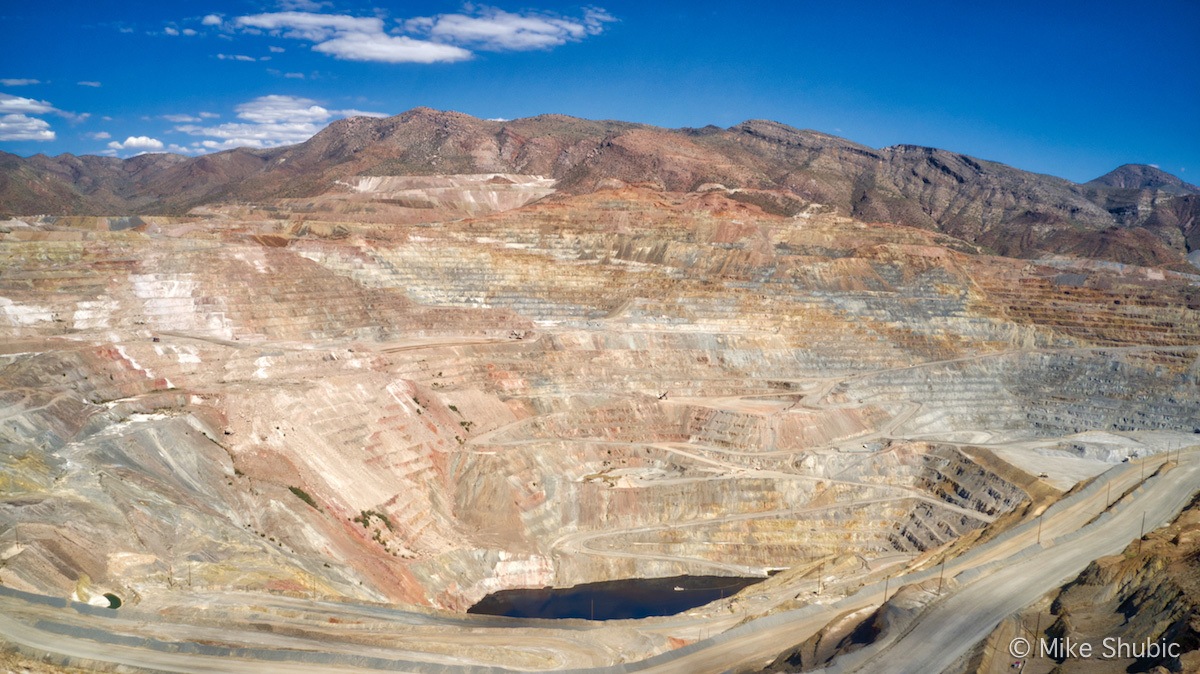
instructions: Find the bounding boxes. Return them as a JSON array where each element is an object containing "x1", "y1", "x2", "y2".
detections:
[{"x1": 404, "y1": 7, "x2": 616, "y2": 52}]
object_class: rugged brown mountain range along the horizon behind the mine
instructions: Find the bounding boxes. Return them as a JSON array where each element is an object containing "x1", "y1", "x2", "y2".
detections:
[{"x1": 0, "y1": 108, "x2": 1200, "y2": 271}]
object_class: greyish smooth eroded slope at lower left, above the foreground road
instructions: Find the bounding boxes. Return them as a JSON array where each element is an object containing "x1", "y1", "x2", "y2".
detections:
[{"x1": 2, "y1": 402, "x2": 382, "y2": 601}]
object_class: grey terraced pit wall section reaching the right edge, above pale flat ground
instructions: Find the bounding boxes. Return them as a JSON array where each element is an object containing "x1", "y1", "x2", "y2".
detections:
[{"x1": 835, "y1": 348, "x2": 1200, "y2": 439}]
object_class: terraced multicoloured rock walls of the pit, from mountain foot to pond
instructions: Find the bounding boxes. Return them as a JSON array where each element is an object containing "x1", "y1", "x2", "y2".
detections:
[{"x1": 0, "y1": 182, "x2": 1200, "y2": 623}]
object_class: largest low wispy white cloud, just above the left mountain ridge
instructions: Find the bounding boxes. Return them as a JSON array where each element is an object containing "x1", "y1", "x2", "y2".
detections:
[{"x1": 175, "y1": 95, "x2": 386, "y2": 151}]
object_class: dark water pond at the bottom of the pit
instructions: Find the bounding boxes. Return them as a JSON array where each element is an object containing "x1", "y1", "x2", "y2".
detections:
[{"x1": 467, "y1": 576, "x2": 764, "y2": 620}]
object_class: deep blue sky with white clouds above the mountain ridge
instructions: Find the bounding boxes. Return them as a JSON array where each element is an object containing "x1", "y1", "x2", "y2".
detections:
[{"x1": 0, "y1": 0, "x2": 1200, "y2": 182}]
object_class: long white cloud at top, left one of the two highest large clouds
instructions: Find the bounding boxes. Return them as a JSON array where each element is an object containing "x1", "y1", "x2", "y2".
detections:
[{"x1": 236, "y1": 11, "x2": 470, "y2": 64}]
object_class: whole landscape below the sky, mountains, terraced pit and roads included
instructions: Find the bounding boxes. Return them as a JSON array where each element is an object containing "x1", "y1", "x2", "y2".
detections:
[{"x1": 0, "y1": 110, "x2": 1200, "y2": 673}]
